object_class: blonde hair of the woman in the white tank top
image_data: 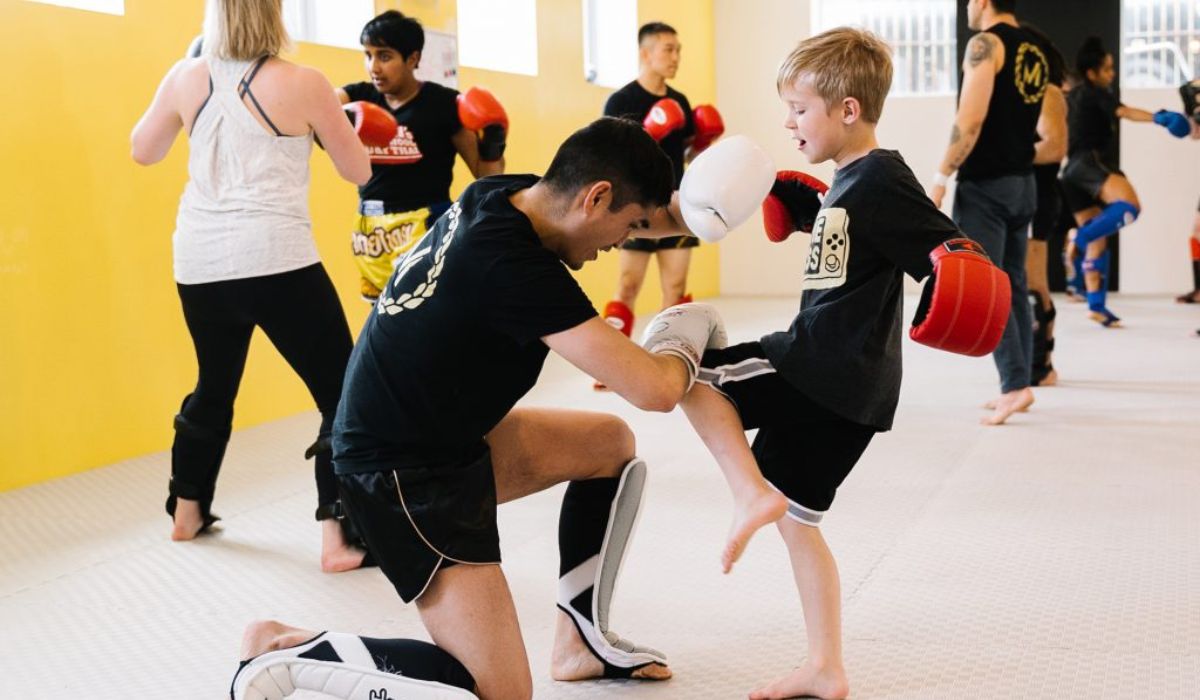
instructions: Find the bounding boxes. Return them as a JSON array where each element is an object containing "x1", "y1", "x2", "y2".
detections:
[{"x1": 204, "y1": 0, "x2": 290, "y2": 61}]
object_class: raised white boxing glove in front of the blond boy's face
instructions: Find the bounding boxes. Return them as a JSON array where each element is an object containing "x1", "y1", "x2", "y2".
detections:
[{"x1": 679, "y1": 134, "x2": 775, "y2": 243}]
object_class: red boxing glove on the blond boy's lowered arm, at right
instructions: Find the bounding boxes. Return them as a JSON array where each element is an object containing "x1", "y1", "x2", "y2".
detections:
[{"x1": 908, "y1": 238, "x2": 1025, "y2": 357}]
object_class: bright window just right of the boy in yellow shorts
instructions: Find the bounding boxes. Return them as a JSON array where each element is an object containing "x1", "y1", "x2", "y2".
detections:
[{"x1": 458, "y1": 0, "x2": 538, "y2": 76}]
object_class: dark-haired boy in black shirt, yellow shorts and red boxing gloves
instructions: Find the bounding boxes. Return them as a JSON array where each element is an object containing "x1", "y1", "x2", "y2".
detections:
[{"x1": 337, "y1": 10, "x2": 504, "y2": 301}]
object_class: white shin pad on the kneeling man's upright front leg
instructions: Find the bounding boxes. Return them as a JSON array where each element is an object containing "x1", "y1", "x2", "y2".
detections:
[{"x1": 558, "y1": 457, "x2": 667, "y2": 678}]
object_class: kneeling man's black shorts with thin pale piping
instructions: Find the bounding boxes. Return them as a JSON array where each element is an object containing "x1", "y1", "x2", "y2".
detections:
[{"x1": 337, "y1": 449, "x2": 500, "y2": 603}]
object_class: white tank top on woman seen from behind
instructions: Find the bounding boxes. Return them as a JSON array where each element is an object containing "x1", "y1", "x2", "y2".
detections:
[{"x1": 174, "y1": 58, "x2": 320, "y2": 285}]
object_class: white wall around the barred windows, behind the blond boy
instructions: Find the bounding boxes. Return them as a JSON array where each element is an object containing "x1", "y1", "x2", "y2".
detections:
[{"x1": 714, "y1": 0, "x2": 1200, "y2": 295}]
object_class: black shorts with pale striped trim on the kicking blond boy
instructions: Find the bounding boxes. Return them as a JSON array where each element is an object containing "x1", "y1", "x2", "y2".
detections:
[{"x1": 696, "y1": 342, "x2": 876, "y2": 525}]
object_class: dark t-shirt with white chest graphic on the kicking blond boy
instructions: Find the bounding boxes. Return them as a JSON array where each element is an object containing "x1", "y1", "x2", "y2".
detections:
[{"x1": 762, "y1": 150, "x2": 962, "y2": 430}]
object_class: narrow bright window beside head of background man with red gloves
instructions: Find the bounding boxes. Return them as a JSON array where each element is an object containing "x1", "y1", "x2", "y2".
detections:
[{"x1": 583, "y1": 0, "x2": 637, "y2": 88}]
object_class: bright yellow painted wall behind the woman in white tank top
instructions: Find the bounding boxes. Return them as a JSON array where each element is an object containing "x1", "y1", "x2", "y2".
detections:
[{"x1": 0, "y1": 0, "x2": 718, "y2": 490}]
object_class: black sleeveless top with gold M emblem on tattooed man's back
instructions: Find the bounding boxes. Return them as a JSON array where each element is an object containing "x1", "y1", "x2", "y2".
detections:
[{"x1": 959, "y1": 23, "x2": 1050, "y2": 180}]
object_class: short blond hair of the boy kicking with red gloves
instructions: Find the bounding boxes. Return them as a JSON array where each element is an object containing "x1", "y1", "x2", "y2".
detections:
[{"x1": 775, "y1": 26, "x2": 892, "y2": 124}]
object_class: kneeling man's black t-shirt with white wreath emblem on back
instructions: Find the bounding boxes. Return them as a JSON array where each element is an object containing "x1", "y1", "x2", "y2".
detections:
[{"x1": 334, "y1": 175, "x2": 596, "y2": 474}]
